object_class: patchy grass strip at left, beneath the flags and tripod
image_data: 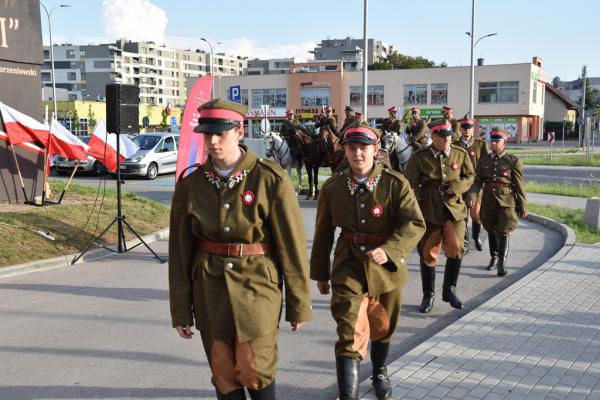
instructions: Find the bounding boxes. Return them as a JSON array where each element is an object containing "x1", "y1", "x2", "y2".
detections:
[{"x1": 0, "y1": 182, "x2": 169, "y2": 267}]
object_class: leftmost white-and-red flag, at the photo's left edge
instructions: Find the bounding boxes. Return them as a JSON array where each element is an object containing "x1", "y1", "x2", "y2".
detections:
[{"x1": 0, "y1": 102, "x2": 50, "y2": 147}]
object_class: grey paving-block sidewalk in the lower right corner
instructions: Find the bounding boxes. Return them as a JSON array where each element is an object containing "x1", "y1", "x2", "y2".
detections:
[{"x1": 361, "y1": 241, "x2": 600, "y2": 400}]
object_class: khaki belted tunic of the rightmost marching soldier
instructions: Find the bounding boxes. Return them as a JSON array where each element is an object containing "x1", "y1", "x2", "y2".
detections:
[{"x1": 469, "y1": 153, "x2": 527, "y2": 235}]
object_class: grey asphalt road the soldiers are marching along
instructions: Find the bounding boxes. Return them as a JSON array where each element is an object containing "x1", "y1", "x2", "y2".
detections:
[{"x1": 0, "y1": 202, "x2": 562, "y2": 400}]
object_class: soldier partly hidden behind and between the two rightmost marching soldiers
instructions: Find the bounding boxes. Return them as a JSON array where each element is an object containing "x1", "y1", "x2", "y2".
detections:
[{"x1": 454, "y1": 118, "x2": 490, "y2": 251}]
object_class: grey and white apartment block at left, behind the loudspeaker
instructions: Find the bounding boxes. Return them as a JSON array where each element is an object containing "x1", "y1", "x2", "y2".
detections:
[{"x1": 42, "y1": 40, "x2": 248, "y2": 107}]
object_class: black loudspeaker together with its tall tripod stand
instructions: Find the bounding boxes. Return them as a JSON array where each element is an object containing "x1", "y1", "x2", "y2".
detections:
[{"x1": 71, "y1": 83, "x2": 166, "y2": 264}]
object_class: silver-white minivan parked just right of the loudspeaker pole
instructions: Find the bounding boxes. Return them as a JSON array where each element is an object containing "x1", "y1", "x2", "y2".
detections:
[{"x1": 121, "y1": 132, "x2": 179, "y2": 179}]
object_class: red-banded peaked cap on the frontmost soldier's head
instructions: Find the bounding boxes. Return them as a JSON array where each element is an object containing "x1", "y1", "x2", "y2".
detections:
[{"x1": 194, "y1": 98, "x2": 248, "y2": 133}]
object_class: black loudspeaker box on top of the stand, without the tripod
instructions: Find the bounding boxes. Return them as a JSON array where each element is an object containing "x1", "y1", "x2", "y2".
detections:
[{"x1": 106, "y1": 83, "x2": 140, "y2": 133}]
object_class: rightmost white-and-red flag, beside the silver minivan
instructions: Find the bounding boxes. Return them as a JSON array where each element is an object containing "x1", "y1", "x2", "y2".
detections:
[{"x1": 87, "y1": 119, "x2": 138, "y2": 172}]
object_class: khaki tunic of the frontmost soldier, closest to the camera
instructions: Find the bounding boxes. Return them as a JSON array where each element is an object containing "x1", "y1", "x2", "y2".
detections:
[{"x1": 169, "y1": 146, "x2": 312, "y2": 343}]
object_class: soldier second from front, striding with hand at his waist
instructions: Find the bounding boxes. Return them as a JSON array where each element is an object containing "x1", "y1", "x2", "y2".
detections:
[{"x1": 310, "y1": 125, "x2": 425, "y2": 400}]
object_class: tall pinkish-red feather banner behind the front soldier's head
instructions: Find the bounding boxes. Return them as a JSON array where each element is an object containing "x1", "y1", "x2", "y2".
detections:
[{"x1": 175, "y1": 76, "x2": 213, "y2": 180}]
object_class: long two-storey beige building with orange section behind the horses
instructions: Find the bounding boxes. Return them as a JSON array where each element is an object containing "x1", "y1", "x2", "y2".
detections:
[{"x1": 197, "y1": 57, "x2": 547, "y2": 142}]
